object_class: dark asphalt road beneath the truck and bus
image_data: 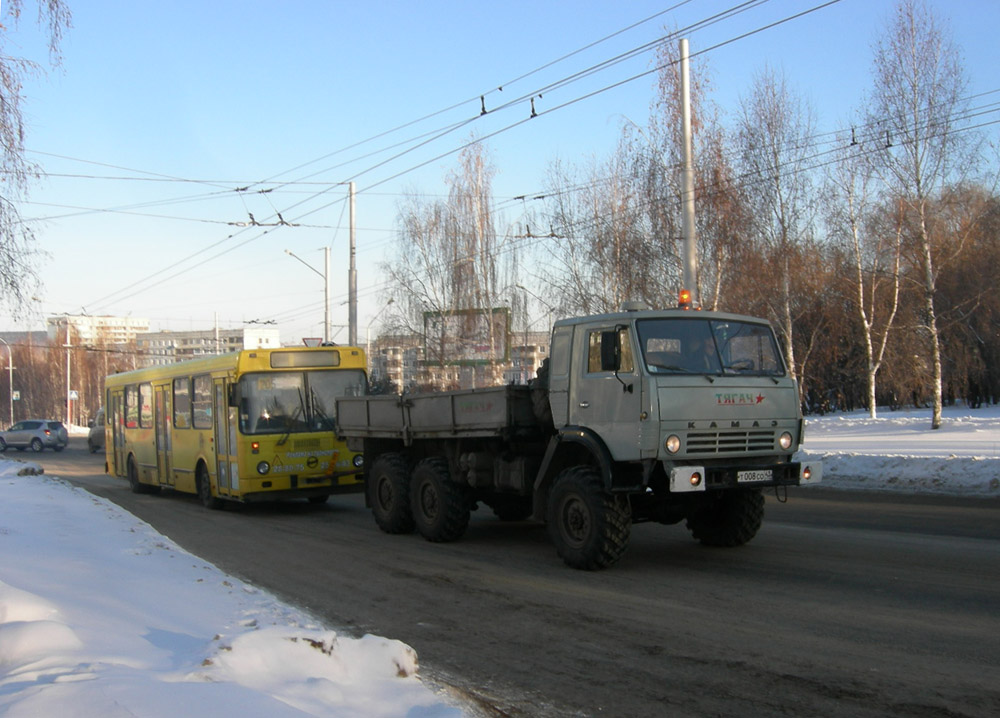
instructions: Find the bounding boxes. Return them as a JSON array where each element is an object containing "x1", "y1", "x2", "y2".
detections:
[{"x1": 32, "y1": 439, "x2": 1000, "y2": 718}]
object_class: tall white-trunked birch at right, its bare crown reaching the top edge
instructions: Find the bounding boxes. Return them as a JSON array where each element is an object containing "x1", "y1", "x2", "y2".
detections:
[{"x1": 868, "y1": 0, "x2": 973, "y2": 429}]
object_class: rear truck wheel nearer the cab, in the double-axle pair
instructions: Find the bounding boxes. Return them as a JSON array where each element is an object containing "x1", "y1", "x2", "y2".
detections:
[{"x1": 410, "y1": 456, "x2": 472, "y2": 542}]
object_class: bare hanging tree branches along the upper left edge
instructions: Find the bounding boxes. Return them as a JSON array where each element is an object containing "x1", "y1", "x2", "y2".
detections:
[{"x1": 0, "y1": 0, "x2": 70, "y2": 310}]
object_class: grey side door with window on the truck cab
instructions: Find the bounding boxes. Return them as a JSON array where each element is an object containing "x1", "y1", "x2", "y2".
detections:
[{"x1": 569, "y1": 325, "x2": 642, "y2": 460}]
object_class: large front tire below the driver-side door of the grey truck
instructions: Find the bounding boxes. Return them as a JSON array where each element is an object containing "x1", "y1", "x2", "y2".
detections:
[{"x1": 546, "y1": 466, "x2": 632, "y2": 571}]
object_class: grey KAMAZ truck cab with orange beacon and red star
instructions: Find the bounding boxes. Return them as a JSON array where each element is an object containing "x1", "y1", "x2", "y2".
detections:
[{"x1": 549, "y1": 309, "x2": 820, "y2": 492}]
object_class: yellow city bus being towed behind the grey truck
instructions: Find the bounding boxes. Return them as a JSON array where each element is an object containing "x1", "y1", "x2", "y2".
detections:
[{"x1": 104, "y1": 346, "x2": 367, "y2": 509}]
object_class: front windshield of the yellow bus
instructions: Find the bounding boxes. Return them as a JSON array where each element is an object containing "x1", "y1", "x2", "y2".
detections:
[{"x1": 239, "y1": 369, "x2": 365, "y2": 434}]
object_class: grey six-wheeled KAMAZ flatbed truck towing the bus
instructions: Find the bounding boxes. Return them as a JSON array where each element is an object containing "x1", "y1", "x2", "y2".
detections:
[{"x1": 337, "y1": 305, "x2": 822, "y2": 569}]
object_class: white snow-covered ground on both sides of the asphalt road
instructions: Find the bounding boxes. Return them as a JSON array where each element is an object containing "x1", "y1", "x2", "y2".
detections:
[{"x1": 0, "y1": 407, "x2": 1000, "y2": 718}]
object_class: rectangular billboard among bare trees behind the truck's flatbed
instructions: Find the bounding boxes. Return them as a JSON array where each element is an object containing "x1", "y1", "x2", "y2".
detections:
[{"x1": 423, "y1": 307, "x2": 510, "y2": 366}]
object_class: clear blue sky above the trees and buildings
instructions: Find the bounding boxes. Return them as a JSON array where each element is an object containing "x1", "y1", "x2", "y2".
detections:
[{"x1": 0, "y1": 0, "x2": 1000, "y2": 341}]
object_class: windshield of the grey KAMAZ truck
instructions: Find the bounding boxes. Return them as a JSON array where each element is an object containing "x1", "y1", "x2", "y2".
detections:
[{"x1": 636, "y1": 317, "x2": 785, "y2": 376}]
